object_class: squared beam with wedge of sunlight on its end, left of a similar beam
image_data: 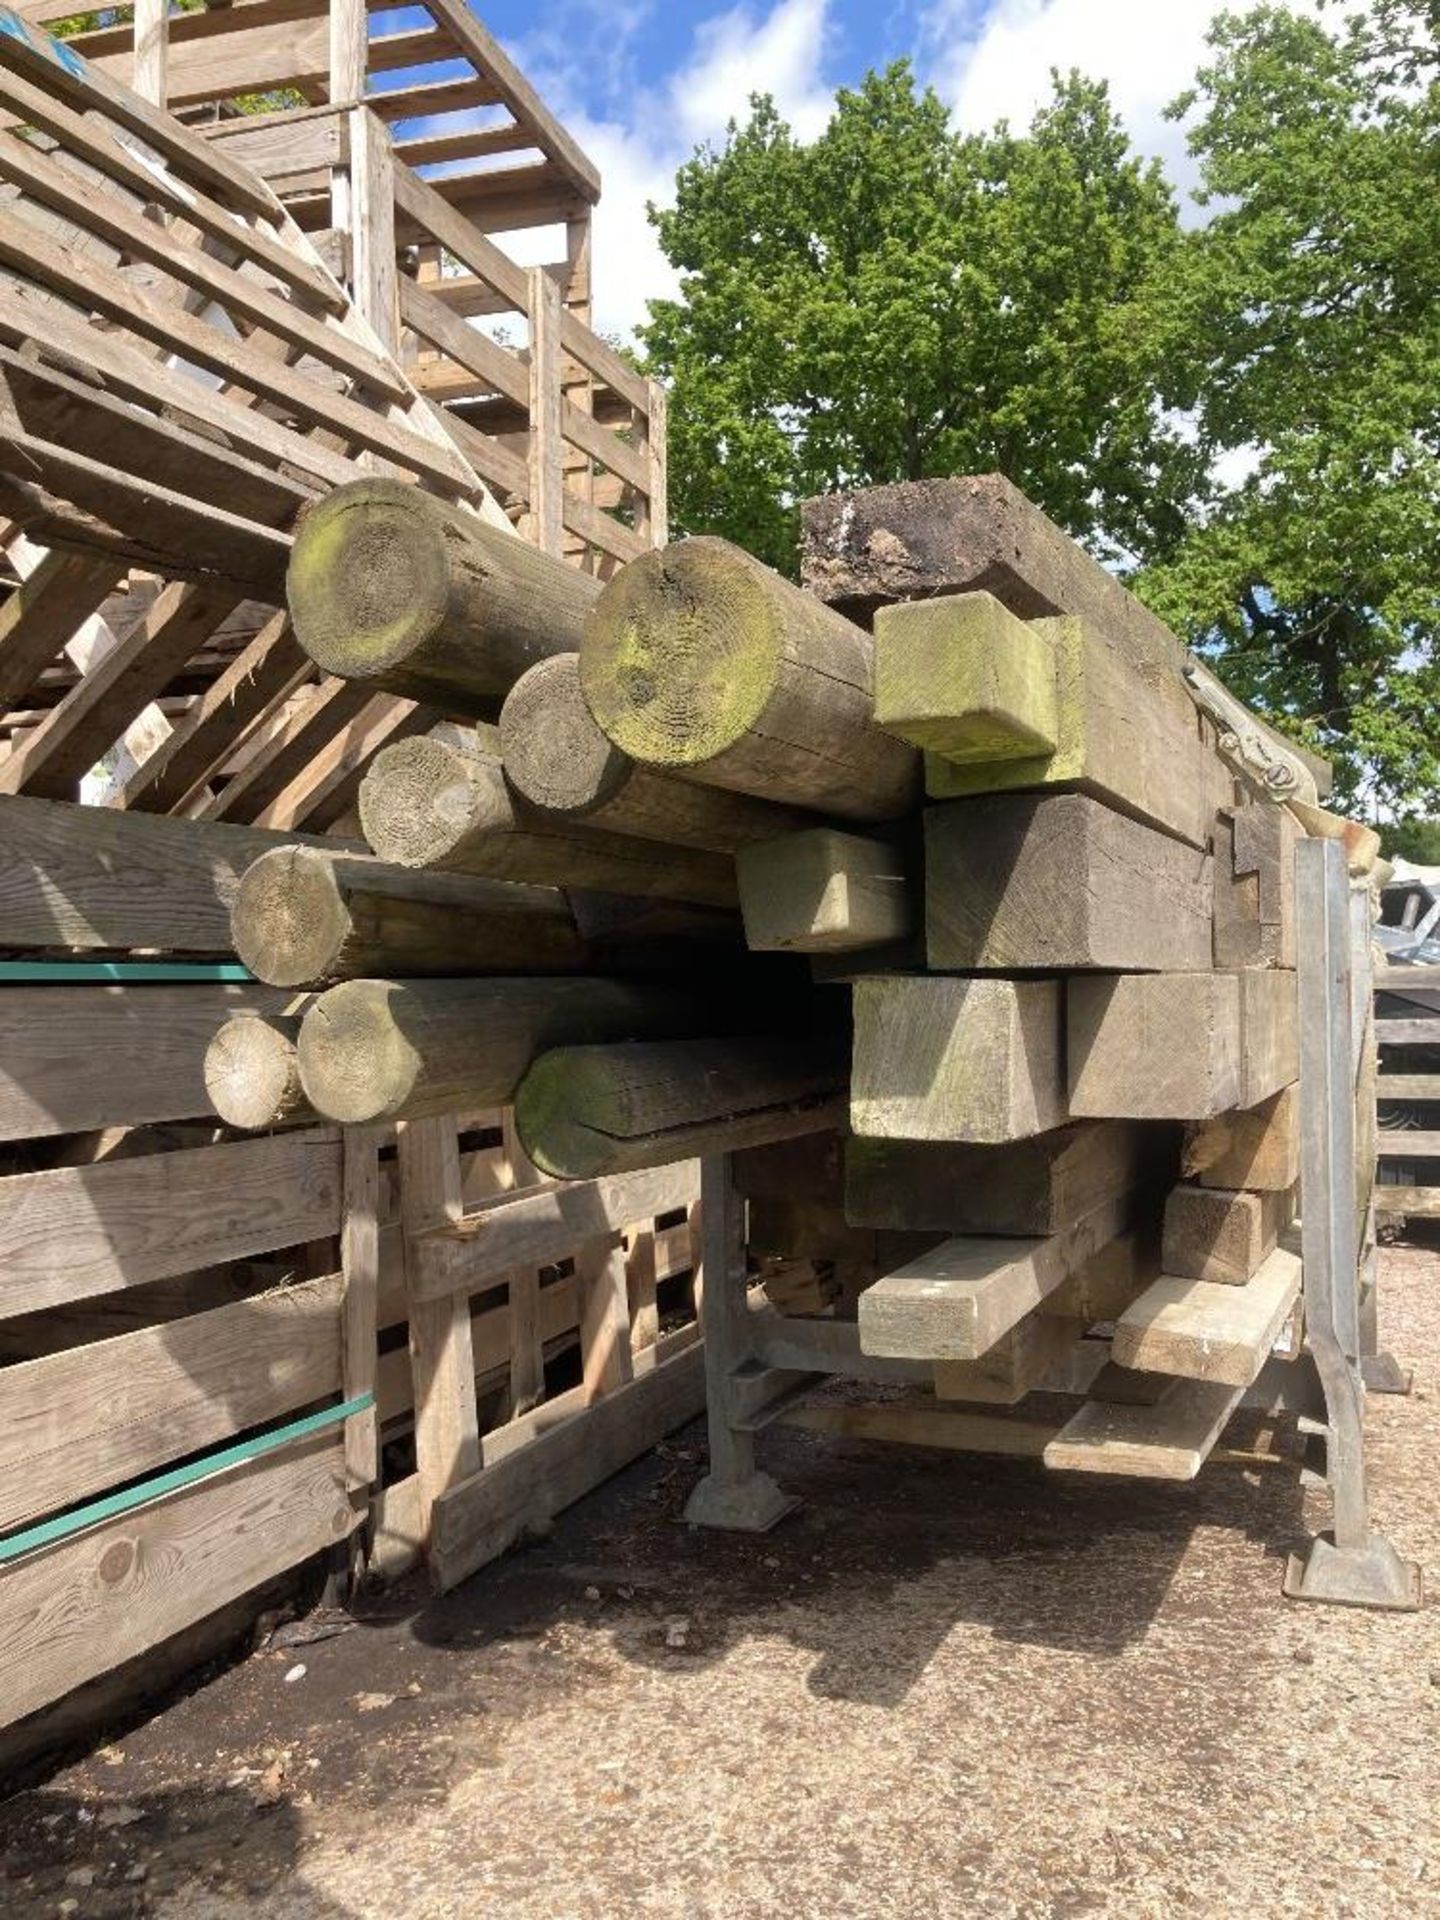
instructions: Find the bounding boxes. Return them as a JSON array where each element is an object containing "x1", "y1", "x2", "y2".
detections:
[{"x1": 851, "y1": 973, "x2": 1069, "y2": 1144}]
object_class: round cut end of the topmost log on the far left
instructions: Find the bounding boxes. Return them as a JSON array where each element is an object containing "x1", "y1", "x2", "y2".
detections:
[{"x1": 286, "y1": 480, "x2": 449, "y2": 680}]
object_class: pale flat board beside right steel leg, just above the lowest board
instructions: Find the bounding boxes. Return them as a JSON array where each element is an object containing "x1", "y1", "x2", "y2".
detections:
[{"x1": 1112, "y1": 1246, "x2": 1300, "y2": 1386}]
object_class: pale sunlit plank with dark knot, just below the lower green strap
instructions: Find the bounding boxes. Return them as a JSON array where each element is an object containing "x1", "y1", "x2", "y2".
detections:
[{"x1": 0, "y1": 1434, "x2": 359, "y2": 1722}]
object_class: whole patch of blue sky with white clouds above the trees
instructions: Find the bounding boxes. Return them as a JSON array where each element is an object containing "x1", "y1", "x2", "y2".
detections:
[{"x1": 408, "y1": 0, "x2": 1313, "y2": 334}]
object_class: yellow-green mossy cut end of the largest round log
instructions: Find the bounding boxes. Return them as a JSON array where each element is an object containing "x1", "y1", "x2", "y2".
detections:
[{"x1": 580, "y1": 536, "x2": 781, "y2": 766}]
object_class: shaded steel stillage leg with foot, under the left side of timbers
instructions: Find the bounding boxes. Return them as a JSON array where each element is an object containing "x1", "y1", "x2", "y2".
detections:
[{"x1": 685, "y1": 1154, "x2": 799, "y2": 1534}]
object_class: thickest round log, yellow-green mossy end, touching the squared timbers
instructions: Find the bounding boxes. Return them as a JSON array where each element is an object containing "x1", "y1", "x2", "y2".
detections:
[{"x1": 580, "y1": 538, "x2": 920, "y2": 820}]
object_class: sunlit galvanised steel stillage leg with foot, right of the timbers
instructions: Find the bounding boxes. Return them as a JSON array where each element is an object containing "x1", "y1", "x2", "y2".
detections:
[{"x1": 1284, "y1": 839, "x2": 1421, "y2": 1609}]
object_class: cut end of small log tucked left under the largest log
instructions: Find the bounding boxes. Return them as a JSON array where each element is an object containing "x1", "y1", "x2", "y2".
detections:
[{"x1": 499, "y1": 653, "x2": 636, "y2": 814}]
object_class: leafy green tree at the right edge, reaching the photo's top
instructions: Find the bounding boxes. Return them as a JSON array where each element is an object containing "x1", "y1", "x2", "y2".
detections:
[{"x1": 1137, "y1": 0, "x2": 1440, "y2": 816}]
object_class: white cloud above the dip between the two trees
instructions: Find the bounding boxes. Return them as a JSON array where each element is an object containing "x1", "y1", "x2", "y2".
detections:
[{"x1": 922, "y1": 0, "x2": 1315, "y2": 190}]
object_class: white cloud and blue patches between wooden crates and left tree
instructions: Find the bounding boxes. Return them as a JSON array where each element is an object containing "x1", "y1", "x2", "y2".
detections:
[{"x1": 520, "y1": 0, "x2": 833, "y2": 336}]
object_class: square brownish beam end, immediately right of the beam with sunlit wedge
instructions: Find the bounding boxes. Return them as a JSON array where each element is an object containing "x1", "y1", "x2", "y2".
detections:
[{"x1": 1066, "y1": 973, "x2": 1242, "y2": 1119}]
